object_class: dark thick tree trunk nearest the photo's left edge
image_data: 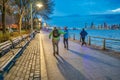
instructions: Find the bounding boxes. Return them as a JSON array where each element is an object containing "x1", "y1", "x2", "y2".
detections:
[{"x1": 2, "y1": 0, "x2": 6, "y2": 34}]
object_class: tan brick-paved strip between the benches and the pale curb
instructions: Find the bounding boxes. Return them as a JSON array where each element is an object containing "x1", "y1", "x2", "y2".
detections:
[{"x1": 5, "y1": 35, "x2": 41, "y2": 80}]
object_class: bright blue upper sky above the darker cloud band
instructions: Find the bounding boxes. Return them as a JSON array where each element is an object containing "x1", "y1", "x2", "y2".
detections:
[{"x1": 53, "y1": 0, "x2": 120, "y2": 16}]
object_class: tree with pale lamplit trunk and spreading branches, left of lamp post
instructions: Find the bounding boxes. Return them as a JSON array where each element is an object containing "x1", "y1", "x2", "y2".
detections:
[{"x1": 10, "y1": 0, "x2": 30, "y2": 34}]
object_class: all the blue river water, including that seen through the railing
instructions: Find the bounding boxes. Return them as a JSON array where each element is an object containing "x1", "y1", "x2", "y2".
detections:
[{"x1": 66, "y1": 30, "x2": 120, "y2": 51}]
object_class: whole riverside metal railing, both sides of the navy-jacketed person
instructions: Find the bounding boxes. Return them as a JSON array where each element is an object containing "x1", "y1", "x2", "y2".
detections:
[{"x1": 69, "y1": 33, "x2": 120, "y2": 52}]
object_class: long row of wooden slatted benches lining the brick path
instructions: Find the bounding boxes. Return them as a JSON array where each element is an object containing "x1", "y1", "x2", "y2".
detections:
[{"x1": 0, "y1": 35, "x2": 30, "y2": 80}]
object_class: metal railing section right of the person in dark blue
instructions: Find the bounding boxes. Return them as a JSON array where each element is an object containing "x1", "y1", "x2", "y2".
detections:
[{"x1": 88, "y1": 36, "x2": 120, "y2": 51}]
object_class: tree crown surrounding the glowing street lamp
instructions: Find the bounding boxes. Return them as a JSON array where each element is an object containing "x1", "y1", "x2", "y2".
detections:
[{"x1": 21, "y1": 0, "x2": 54, "y2": 30}]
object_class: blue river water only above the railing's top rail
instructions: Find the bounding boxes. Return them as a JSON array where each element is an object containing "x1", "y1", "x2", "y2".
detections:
[{"x1": 69, "y1": 30, "x2": 120, "y2": 39}]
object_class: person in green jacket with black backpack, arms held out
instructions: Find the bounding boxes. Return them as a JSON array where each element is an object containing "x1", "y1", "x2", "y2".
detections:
[{"x1": 49, "y1": 27, "x2": 65, "y2": 56}]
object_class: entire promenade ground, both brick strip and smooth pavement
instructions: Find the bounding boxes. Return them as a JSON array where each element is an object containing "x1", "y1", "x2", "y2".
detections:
[{"x1": 5, "y1": 32, "x2": 120, "y2": 80}]
